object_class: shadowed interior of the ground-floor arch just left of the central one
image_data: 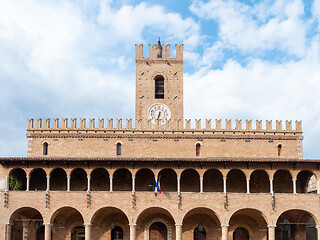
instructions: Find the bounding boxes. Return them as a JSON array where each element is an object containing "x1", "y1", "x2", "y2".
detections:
[{"x1": 90, "y1": 206, "x2": 130, "y2": 239}]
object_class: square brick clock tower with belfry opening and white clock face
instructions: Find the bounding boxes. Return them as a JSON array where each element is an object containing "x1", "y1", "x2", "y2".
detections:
[{"x1": 135, "y1": 40, "x2": 183, "y2": 125}]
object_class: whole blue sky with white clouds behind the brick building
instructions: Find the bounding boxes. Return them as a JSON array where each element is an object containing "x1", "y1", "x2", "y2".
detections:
[{"x1": 0, "y1": 0, "x2": 320, "y2": 159}]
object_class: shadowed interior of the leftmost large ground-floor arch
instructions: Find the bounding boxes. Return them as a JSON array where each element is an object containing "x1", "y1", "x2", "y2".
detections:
[{"x1": 9, "y1": 207, "x2": 44, "y2": 240}]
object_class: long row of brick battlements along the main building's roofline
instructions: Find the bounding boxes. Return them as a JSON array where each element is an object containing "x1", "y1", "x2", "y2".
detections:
[{"x1": 27, "y1": 118, "x2": 302, "y2": 134}]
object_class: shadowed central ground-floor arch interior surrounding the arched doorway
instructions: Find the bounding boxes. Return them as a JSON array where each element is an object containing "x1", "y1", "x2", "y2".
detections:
[{"x1": 136, "y1": 207, "x2": 176, "y2": 240}]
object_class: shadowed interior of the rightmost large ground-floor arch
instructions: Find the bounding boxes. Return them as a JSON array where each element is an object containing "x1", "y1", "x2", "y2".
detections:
[{"x1": 275, "y1": 209, "x2": 318, "y2": 240}]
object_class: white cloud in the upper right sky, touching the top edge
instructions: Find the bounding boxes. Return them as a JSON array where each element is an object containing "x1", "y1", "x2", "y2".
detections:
[{"x1": 190, "y1": 0, "x2": 306, "y2": 57}]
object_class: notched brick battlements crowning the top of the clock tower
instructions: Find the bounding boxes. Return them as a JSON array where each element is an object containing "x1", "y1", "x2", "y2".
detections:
[{"x1": 136, "y1": 44, "x2": 183, "y2": 61}]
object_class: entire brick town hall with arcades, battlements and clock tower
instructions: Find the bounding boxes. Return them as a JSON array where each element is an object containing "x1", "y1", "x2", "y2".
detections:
[{"x1": 0, "y1": 41, "x2": 320, "y2": 240}]
